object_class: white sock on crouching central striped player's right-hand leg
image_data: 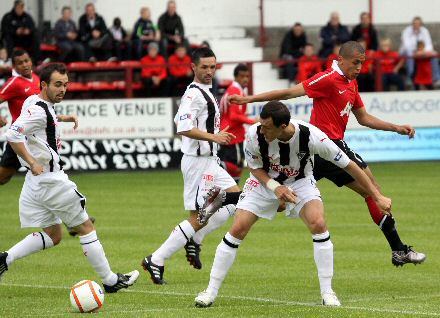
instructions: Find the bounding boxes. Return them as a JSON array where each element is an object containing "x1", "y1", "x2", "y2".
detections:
[{"x1": 312, "y1": 231, "x2": 333, "y2": 293}]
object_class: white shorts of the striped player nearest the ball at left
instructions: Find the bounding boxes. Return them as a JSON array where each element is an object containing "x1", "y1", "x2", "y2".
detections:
[{"x1": 19, "y1": 171, "x2": 89, "y2": 228}]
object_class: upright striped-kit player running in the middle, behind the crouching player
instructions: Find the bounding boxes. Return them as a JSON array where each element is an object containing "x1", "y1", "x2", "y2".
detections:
[{"x1": 142, "y1": 48, "x2": 240, "y2": 284}]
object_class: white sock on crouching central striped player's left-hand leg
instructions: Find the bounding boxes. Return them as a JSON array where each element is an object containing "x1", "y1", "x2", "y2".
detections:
[{"x1": 206, "y1": 232, "x2": 241, "y2": 296}]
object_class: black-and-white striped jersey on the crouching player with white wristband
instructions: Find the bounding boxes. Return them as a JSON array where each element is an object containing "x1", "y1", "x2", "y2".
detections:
[{"x1": 245, "y1": 119, "x2": 350, "y2": 185}]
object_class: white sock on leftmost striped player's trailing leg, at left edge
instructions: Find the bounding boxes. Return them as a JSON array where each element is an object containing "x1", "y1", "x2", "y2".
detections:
[{"x1": 6, "y1": 231, "x2": 53, "y2": 266}]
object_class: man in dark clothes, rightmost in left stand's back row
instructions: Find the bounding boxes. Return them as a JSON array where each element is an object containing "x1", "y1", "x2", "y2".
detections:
[{"x1": 157, "y1": 0, "x2": 190, "y2": 58}]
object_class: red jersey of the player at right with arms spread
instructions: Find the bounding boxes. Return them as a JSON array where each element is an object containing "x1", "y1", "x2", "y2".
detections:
[{"x1": 302, "y1": 61, "x2": 364, "y2": 139}]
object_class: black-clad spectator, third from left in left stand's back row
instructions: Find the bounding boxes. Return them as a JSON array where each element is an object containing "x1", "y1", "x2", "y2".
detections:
[{"x1": 79, "y1": 3, "x2": 112, "y2": 62}]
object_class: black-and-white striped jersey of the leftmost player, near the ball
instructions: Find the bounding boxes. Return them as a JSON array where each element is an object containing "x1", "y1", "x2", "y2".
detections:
[{"x1": 5, "y1": 95, "x2": 62, "y2": 173}]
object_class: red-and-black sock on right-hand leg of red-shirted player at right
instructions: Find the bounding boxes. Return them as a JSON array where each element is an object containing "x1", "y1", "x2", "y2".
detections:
[{"x1": 365, "y1": 197, "x2": 405, "y2": 251}]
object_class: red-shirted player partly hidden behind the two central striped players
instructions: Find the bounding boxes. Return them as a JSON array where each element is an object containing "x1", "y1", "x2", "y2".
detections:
[{"x1": 218, "y1": 63, "x2": 255, "y2": 184}]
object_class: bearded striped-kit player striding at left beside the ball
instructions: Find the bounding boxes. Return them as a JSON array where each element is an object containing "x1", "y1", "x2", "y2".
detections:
[{"x1": 0, "y1": 63, "x2": 139, "y2": 293}]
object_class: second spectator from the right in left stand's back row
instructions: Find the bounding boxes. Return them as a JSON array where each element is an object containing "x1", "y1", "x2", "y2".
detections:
[{"x1": 131, "y1": 7, "x2": 160, "y2": 60}]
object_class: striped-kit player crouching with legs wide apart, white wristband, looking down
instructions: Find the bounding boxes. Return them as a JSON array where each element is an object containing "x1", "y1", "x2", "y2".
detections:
[{"x1": 195, "y1": 101, "x2": 391, "y2": 307}]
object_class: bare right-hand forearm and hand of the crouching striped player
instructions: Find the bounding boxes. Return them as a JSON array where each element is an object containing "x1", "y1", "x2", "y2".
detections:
[{"x1": 344, "y1": 160, "x2": 391, "y2": 215}]
